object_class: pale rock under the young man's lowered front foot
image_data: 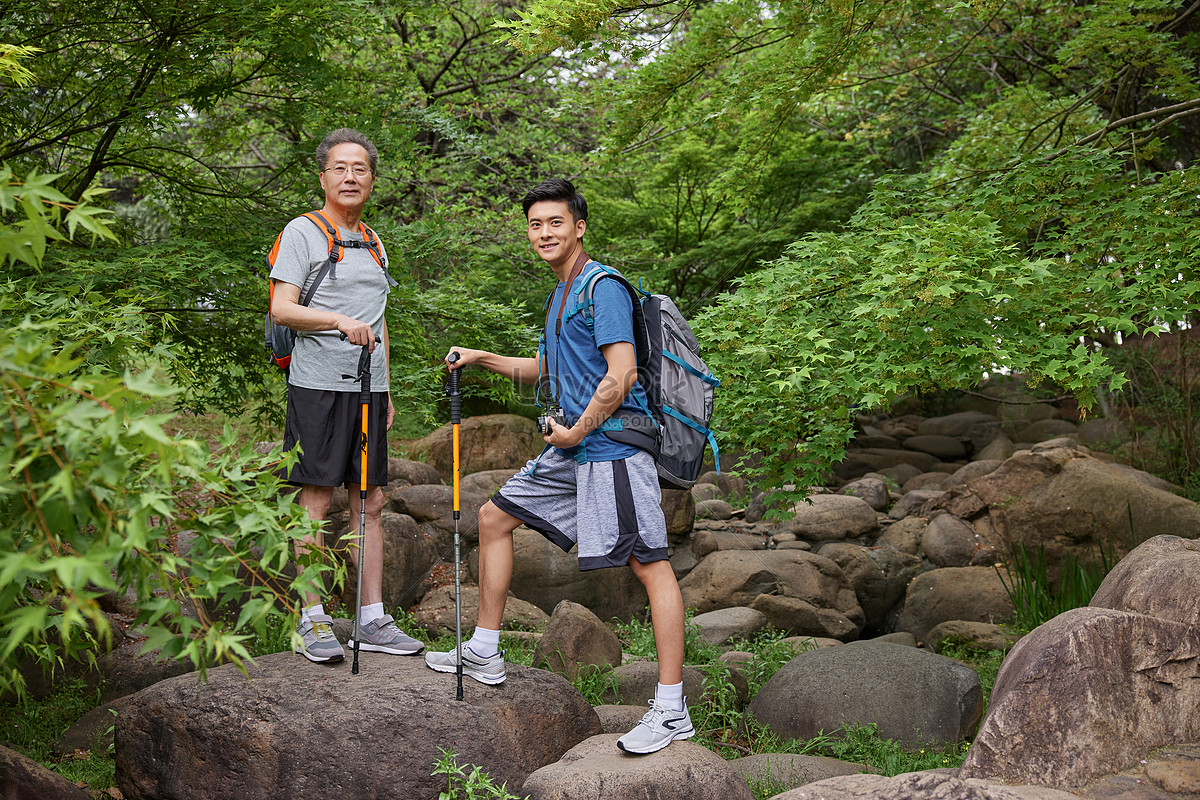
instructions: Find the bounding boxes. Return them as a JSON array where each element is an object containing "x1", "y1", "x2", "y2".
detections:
[{"x1": 522, "y1": 734, "x2": 754, "y2": 800}]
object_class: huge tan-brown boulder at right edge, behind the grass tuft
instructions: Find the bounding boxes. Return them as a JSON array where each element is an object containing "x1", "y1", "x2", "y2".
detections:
[{"x1": 940, "y1": 439, "x2": 1200, "y2": 581}]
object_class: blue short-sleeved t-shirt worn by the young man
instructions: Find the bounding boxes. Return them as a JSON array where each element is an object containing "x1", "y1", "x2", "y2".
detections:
[{"x1": 545, "y1": 269, "x2": 646, "y2": 462}]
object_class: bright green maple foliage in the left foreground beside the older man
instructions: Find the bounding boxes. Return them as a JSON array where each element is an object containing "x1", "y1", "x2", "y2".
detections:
[{"x1": 0, "y1": 320, "x2": 331, "y2": 691}]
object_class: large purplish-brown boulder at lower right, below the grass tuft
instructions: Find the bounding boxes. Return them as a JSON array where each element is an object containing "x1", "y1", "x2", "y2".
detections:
[{"x1": 960, "y1": 606, "x2": 1200, "y2": 789}]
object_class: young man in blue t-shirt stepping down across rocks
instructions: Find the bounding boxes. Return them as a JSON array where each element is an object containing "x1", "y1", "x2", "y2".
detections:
[{"x1": 425, "y1": 180, "x2": 695, "y2": 753}]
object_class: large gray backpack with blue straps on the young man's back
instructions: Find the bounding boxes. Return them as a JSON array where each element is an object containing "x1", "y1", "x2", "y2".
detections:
[{"x1": 569, "y1": 261, "x2": 721, "y2": 489}]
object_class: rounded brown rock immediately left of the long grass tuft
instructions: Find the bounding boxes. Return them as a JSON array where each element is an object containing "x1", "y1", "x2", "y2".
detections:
[{"x1": 896, "y1": 566, "x2": 1013, "y2": 642}]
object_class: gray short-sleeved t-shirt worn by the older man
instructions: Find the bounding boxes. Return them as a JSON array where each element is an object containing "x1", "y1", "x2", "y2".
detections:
[{"x1": 271, "y1": 217, "x2": 391, "y2": 392}]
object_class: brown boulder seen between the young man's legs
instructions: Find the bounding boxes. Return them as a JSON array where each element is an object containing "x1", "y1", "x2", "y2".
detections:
[{"x1": 484, "y1": 525, "x2": 649, "y2": 621}]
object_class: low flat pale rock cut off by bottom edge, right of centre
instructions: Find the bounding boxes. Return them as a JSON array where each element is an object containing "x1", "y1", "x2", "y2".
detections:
[{"x1": 772, "y1": 771, "x2": 1084, "y2": 800}]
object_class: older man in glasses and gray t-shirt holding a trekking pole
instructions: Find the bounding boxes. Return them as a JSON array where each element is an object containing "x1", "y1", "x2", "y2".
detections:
[{"x1": 270, "y1": 128, "x2": 424, "y2": 662}]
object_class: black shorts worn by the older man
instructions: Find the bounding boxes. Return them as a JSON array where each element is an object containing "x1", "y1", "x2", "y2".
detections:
[{"x1": 283, "y1": 385, "x2": 388, "y2": 488}]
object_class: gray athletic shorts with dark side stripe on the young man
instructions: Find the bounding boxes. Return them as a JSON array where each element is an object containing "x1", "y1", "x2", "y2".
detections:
[{"x1": 492, "y1": 449, "x2": 667, "y2": 571}]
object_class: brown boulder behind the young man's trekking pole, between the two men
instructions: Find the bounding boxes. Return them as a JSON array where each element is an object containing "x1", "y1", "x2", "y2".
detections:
[{"x1": 408, "y1": 414, "x2": 546, "y2": 482}]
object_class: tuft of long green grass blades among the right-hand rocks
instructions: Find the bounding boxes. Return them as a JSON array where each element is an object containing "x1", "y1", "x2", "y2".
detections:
[{"x1": 996, "y1": 545, "x2": 1118, "y2": 632}]
